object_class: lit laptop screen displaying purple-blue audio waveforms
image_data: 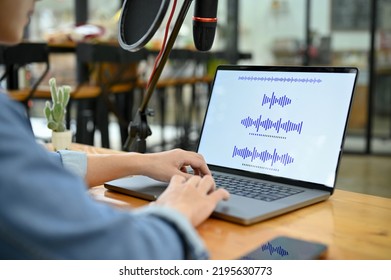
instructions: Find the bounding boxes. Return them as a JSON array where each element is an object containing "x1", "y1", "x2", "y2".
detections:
[{"x1": 198, "y1": 66, "x2": 358, "y2": 187}]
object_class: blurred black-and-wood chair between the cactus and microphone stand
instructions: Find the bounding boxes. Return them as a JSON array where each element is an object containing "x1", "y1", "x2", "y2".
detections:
[{"x1": 71, "y1": 43, "x2": 146, "y2": 148}]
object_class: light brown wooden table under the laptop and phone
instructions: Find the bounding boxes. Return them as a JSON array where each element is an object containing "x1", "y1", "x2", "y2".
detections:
[{"x1": 69, "y1": 144, "x2": 391, "y2": 259}]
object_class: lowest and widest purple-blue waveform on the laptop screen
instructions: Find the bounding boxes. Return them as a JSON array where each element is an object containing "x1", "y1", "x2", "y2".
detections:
[{"x1": 232, "y1": 146, "x2": 294, "y2": 166}]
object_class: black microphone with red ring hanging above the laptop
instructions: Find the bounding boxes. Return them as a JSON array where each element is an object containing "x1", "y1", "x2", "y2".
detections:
[{"x1": 193, "y1": 0, "x2": 217, "y2": 51}]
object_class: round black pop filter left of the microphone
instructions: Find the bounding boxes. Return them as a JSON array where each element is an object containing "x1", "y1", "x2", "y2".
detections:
[{"x1": 118, "y1": 0, "x2": 170, "y2": 52}]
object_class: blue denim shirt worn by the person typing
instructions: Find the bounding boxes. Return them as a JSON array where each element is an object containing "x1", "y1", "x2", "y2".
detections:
[{"x1": 0, "y1": 93, "x2": 208, "y2": 259}]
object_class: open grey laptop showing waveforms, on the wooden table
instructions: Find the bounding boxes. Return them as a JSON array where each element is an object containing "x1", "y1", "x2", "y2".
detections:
[{"x1": 105, "y1": 65, "x2": 358, "y2": 225}]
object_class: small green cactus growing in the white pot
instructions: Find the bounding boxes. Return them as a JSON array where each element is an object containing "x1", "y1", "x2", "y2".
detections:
[{"x1": 44, "y1": 78, "x2": 71, "y2": 132}]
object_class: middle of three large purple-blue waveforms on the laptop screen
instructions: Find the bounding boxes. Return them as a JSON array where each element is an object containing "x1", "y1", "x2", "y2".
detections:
[{"x1": 240, "y1": 115, "x2": 303, "y2": 134}]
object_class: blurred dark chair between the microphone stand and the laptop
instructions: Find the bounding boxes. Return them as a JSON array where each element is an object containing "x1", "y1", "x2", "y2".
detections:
[{"x1": 139, "y1": 49, "x2": 212, "y2": 150}]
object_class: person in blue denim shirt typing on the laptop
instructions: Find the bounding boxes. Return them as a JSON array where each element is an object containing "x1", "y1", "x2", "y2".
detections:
[{"x1": 0, "y1": 0, "x2": 229, "y2": 259}]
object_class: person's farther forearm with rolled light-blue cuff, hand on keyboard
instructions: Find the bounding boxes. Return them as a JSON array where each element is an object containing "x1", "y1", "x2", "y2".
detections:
[{"x1": 59, "y1": 149, "x2": 214, "y2": 187}]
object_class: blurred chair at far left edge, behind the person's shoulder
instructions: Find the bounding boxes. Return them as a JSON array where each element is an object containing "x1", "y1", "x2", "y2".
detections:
[{"x1": 0, "y1": 43, "x2": 50, "y2": 113}]
